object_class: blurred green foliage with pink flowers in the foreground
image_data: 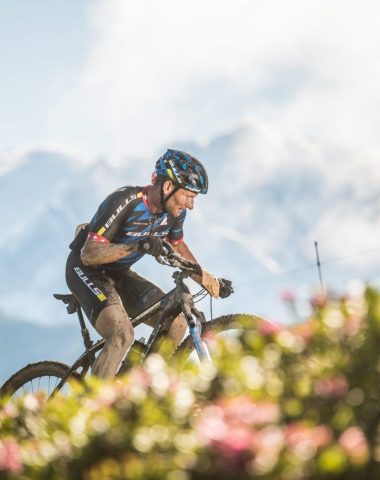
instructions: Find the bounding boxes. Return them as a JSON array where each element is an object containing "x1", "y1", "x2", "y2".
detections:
[{"x1": 0, "y1": 289, "x2": 380, "y2": 480}]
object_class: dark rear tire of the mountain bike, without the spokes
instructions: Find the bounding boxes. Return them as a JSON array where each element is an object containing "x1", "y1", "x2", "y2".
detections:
[{"x1": 0, "y1": 360, "x2": 81, "y2": 397}]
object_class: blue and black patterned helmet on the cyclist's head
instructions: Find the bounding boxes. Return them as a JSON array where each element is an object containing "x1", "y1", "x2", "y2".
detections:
[{"x1": 155, "y1": 149, "x2": 208, "y2": 193}]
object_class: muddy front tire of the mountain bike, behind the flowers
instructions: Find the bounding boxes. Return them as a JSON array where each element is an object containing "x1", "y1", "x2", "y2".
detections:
[{"x1": 174, "y1": 313, "x2": 270, "y2": 358}]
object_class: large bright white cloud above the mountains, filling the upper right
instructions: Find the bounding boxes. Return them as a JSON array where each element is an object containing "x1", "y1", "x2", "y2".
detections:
[{"x1": 52, "y1": 0, "x2": 380, "y2": 161}]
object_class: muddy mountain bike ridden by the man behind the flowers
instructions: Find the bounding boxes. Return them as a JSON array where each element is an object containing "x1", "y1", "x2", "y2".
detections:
[{"x1": 0, "y1": 242, "x2": 264, "y2": 397}]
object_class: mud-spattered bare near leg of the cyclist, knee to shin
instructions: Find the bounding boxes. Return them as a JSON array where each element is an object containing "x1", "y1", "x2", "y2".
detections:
[{"x1": 92, "y1": 304, "x2": 134, "y2": 378}]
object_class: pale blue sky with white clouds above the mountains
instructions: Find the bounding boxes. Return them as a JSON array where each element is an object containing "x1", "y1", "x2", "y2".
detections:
[{"x1": 0, "y1": 0, "x2": 380, "y2": 322}]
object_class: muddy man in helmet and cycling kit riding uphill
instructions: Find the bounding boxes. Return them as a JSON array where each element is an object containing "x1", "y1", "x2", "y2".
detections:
[{"x1": 66, "y1": 149, "x2": 233, "y2": 378}]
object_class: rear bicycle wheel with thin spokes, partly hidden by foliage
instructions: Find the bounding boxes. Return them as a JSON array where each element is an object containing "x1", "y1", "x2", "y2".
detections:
[{"x1": 0, "y1": 361, "x2": 81, "y2": 398}]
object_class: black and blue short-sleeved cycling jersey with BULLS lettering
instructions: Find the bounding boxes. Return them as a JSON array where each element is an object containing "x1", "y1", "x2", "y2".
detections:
[{"x1": 70, "y1": 186, "x2": 186, "y2": 271}]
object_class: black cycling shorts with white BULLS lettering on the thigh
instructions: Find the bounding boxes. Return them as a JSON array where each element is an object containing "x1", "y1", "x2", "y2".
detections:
[{"x1": 66, "y1": 250, "x2": 165, "y2": 326}]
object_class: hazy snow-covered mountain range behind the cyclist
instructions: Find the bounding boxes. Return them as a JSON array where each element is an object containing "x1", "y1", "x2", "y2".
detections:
[{"x1": 0, "y1": 121, "x2": 380, "y2": 384}]
